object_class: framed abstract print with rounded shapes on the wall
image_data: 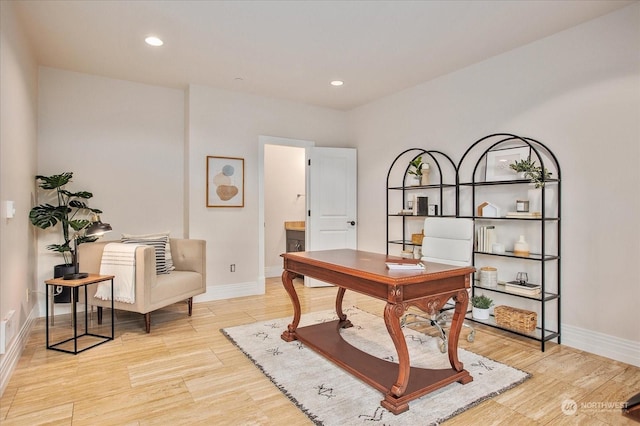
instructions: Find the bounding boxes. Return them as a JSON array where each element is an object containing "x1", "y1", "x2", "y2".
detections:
[{"x1": 206, "y1": 155, "x2": 244, "y2": 207}]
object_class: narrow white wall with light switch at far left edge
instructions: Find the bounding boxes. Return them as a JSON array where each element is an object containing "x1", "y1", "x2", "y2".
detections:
[{"x1": 0, "y1": 1, "x2": 38, "y2": 394}]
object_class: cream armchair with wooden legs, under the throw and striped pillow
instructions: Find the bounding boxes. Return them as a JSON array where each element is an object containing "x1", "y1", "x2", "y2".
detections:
[{"x1": 78, "y1": 238, "x2": 206, "y2": 333}]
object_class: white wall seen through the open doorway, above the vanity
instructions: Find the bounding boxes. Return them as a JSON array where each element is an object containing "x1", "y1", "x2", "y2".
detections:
[{"x1": 264, "y1": 145, "x2": 306, "y2": 277}]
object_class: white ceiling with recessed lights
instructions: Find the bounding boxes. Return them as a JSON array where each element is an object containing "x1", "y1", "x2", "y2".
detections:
[{"x1": 16, "y1": 0, "x2": 634, "y2": 110}]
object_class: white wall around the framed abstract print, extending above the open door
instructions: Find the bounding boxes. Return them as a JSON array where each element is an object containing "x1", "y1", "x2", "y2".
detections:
[{"x1": 188, "y1": 85, "x2": 349, "y2": 300}]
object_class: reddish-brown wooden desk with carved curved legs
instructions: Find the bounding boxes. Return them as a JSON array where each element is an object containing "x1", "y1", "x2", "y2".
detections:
[{"x1": 281, "y1": 249, "x2": 475, "y2": 414}]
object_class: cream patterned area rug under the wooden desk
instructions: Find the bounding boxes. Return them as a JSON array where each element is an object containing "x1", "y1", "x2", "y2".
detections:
[{"x1": 221, "y1": 308, "x2": 530, "y2": 426}]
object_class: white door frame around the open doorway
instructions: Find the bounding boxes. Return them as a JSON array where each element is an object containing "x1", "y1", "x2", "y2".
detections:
[{"x1": 258, "y1": 135, "x2": 315, "y2": 294}]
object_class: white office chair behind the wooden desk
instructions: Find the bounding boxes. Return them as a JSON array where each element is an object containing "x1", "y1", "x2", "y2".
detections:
[{"x1": 401, "y1": 216, "x2": 476, "y2": 353}]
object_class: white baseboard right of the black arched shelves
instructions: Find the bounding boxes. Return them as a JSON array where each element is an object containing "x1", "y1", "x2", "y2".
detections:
[{"x1": 562, "y1": 324, "x2": 640, "y2": 367}]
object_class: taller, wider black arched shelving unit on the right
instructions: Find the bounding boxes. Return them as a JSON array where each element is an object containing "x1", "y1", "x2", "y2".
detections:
[{"x1": 456, "y1": 133, "x2": 561, "y2": 351}]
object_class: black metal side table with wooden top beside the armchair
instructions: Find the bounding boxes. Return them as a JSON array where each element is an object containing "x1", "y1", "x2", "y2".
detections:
[{"x1": 44, "y1": 274, "x2": 115, "y2": 355}]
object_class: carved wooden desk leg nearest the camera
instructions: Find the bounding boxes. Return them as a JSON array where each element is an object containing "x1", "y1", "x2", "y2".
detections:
[{"x1": 380, "y1": 303, "x2": 411, "y2": 414}]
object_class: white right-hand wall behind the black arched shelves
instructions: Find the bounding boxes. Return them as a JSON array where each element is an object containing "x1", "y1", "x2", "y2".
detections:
[{"x1": 350, "y1": 4, "x2": 640, "y2": 365}]
